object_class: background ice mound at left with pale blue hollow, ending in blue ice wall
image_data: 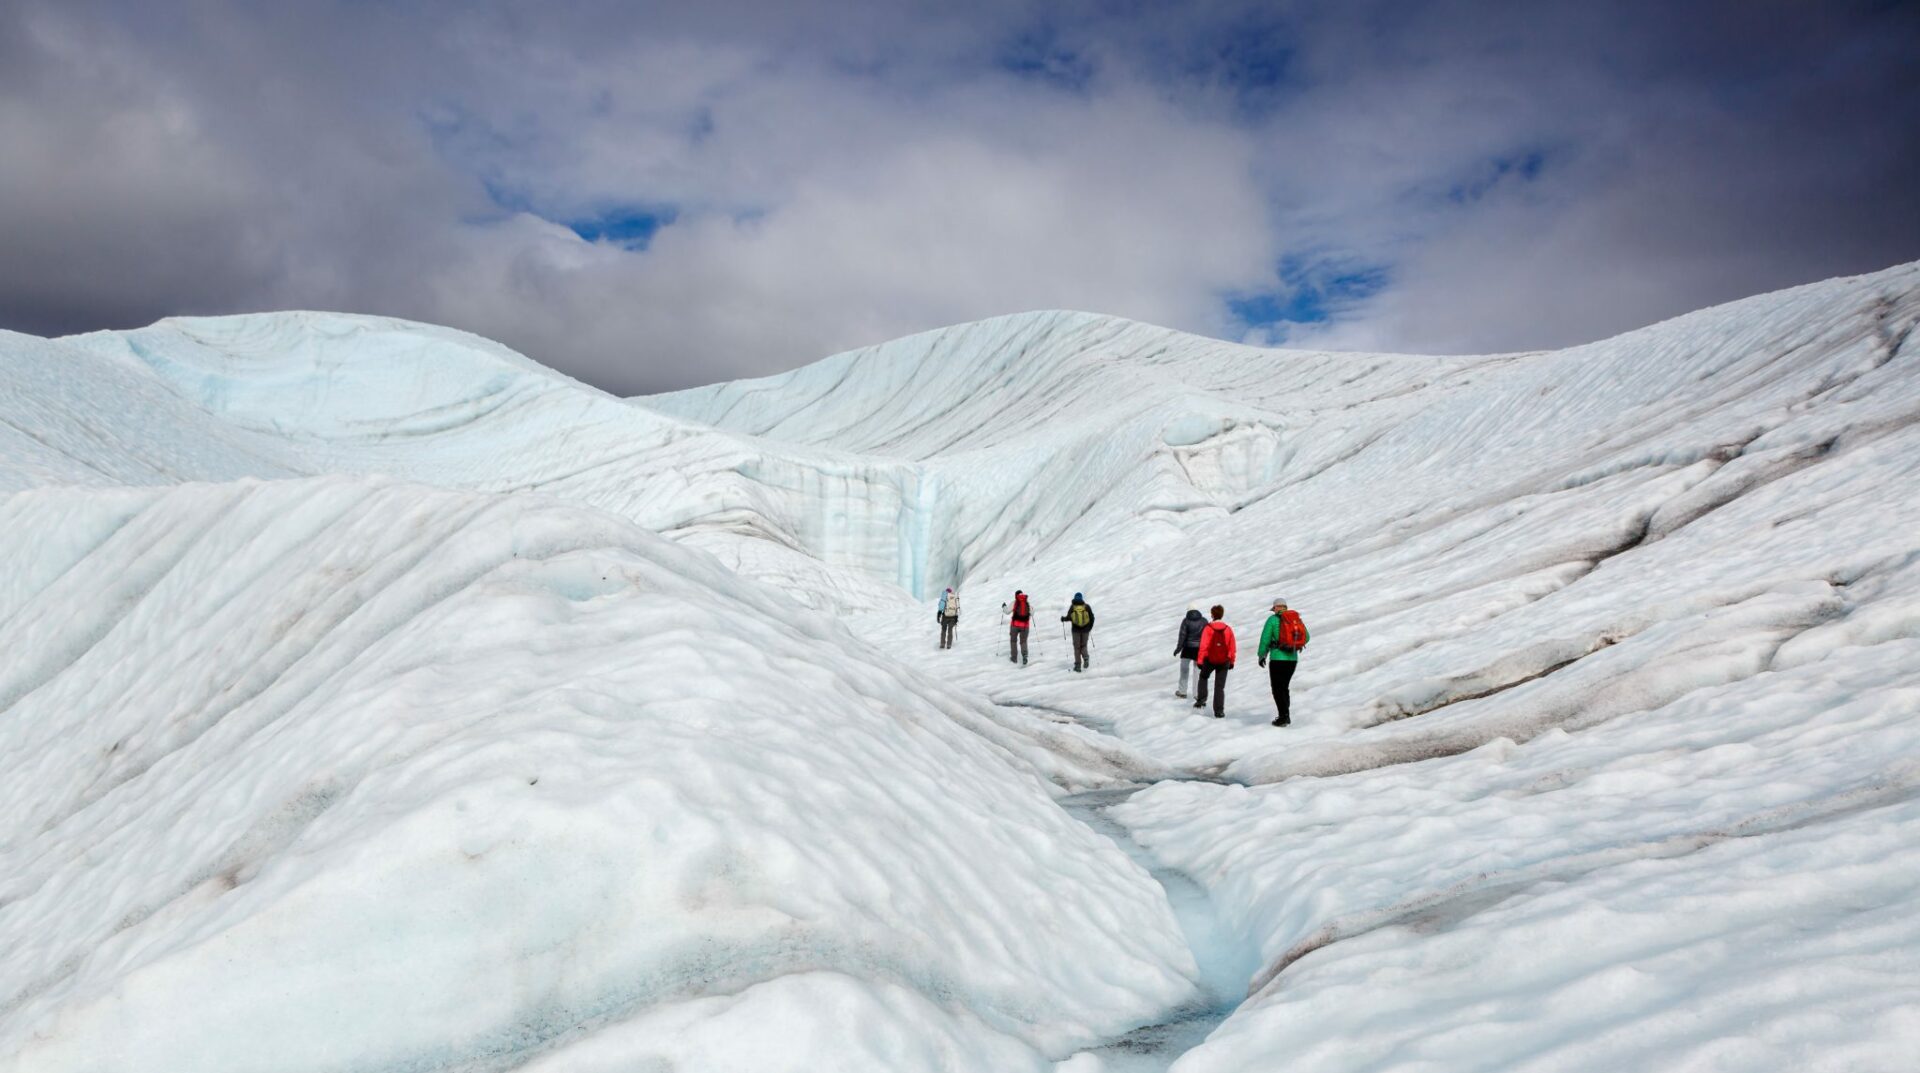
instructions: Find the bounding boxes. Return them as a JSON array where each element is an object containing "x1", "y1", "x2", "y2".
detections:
[{"x1": 31, "y1": 313, "x2": 960, "y2": 608}]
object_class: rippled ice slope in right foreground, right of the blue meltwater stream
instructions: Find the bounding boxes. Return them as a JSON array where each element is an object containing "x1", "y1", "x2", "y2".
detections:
[{"x1": 1116, "y1": 639, "x2": 1920, "y2": 1071}]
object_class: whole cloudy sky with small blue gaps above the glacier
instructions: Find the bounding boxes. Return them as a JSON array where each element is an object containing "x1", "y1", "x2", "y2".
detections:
[{"x1": 0, "y1": 0, "x2": 1920, "y2": 395}]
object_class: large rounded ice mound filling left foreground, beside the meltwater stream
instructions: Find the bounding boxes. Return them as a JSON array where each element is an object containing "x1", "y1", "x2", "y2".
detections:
[{"x1": 0, "y1": 478, "x2": 1196, "y2": 1073}]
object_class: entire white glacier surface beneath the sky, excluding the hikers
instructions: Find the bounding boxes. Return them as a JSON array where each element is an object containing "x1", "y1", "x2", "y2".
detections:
[{"x1": 11, "y1": 259, "x2": 1920, "y2": 1073}]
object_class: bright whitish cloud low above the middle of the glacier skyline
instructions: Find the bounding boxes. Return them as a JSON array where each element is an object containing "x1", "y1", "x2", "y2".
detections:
[{"x1": 430, "y1": 77, "x2": 1275, "y2": 386}]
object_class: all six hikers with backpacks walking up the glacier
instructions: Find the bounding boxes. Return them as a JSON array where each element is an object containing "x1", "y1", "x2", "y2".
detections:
[{"x1": 935, "y1": 589, "x2": 1311, "y2": 726}]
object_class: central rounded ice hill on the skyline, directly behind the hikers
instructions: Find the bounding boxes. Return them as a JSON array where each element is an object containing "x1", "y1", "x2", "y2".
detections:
[{"x1": 641, "y1": 313, "x2": 1501, "y2": 597}]
